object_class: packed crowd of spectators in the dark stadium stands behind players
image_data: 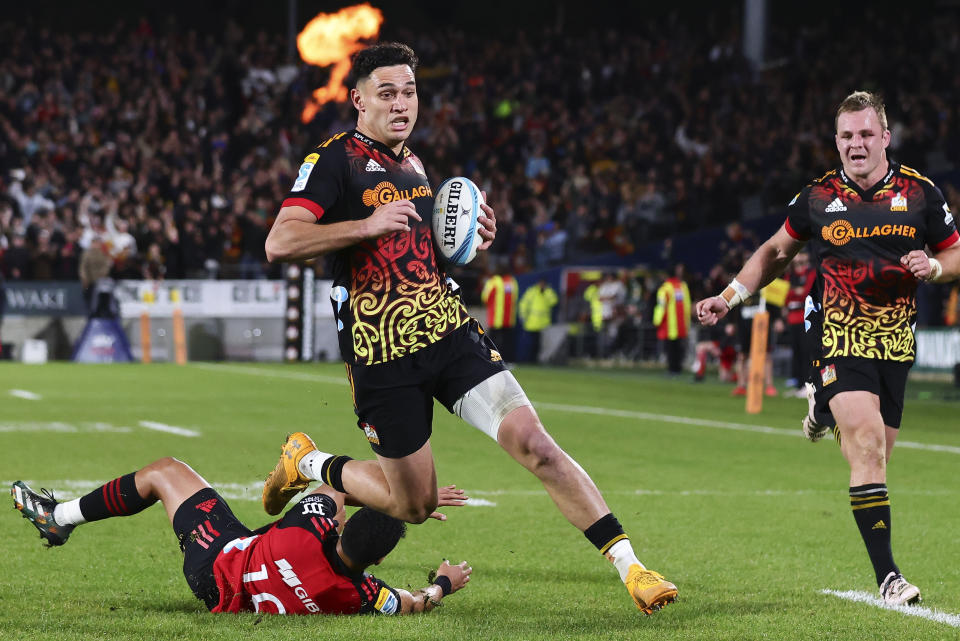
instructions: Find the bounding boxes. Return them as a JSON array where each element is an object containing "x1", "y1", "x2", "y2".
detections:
[{"x1": 0, "y1": 9, "x2": 960, "y2": 322}]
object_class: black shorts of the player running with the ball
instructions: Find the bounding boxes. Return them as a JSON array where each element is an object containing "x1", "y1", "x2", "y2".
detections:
[{"x1": 347, "y1": 319, "x2": 506, "y2": 458}]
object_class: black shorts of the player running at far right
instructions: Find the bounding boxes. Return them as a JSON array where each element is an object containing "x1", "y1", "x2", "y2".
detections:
[{"x1": 811, "y1": 357, "x2": 913, "y2": 429}]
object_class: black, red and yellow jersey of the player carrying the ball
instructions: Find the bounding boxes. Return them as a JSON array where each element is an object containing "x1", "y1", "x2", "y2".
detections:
[{"x1": 283, "y1": 130, "x2": 469, "y2": 365}]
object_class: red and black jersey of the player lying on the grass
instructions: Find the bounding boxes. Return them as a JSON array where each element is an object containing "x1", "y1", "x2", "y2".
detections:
[{"x1": 211, "y1": 494, "x2": 400, "y2": 614}]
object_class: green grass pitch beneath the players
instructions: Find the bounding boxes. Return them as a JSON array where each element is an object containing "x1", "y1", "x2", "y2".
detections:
[{"x1": 0, "y1": 363, "x2": 960, "y2": 641}]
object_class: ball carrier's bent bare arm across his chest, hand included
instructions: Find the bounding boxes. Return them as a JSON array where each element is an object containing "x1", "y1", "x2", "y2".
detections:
[{"x1": 265, "y1": 200, "x2": 424, "y2": 262}]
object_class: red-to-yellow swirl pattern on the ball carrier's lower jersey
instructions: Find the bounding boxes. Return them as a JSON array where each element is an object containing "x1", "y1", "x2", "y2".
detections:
[{"x1": 350, "y1": 225, "x2": 467, "y2": 365}]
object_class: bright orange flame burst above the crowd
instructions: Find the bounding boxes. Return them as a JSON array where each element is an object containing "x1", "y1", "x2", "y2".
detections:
[{"x1": 297, "y1": 3, "x2": 383, "y2": 123}]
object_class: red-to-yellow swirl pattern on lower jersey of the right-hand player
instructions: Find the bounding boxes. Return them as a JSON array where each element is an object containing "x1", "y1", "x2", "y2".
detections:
[{"x1": 821, "y1": 258, "x2": 916, "y2": 362}]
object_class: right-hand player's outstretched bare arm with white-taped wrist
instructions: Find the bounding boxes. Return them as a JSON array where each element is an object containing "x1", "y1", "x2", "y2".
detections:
[{"x1": 697, "y1": 225, "x2": 803, "y2": 326}]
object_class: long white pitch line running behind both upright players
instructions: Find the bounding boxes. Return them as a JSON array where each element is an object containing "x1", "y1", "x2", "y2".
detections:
[{"x1": 191, "y1": 363, "x2": 960, "y2": 454}]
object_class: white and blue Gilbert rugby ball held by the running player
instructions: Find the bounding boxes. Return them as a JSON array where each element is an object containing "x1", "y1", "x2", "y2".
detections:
[{"x1": 432, "y1": 176, "x2": 484, "y2": 265}]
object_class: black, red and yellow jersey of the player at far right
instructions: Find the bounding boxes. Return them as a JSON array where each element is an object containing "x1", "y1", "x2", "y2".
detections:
[{"x1": 784, "y1": 162, "x2": 960, "y2": 362}]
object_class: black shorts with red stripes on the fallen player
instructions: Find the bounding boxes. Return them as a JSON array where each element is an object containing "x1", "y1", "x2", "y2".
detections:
[{"x1": 173, "y1": 487, "x2": 254, "y2": 610}]
